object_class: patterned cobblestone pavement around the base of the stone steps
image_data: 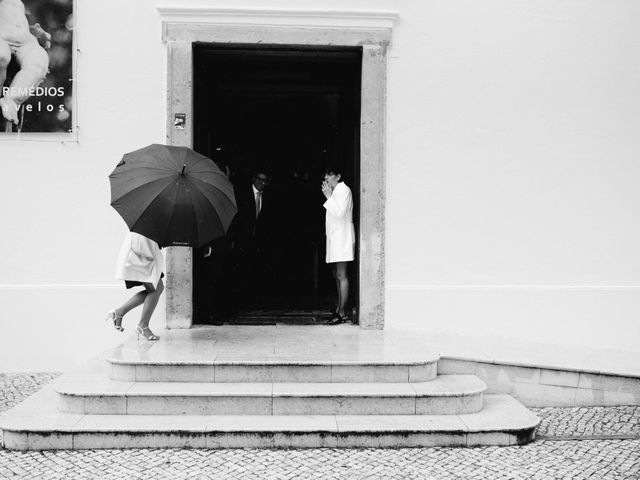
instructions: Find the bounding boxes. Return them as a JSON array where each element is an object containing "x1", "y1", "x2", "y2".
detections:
[{"x1": 0, "y1": 373, "x2": 640, "y2": 480}]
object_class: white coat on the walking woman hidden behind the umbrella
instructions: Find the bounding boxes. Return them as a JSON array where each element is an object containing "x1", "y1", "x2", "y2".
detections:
[{"x1": 116, "y1": 232, "x2": 164, "y2": 287}]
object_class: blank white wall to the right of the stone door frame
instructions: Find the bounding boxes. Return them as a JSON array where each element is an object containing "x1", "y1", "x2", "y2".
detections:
[{"x1": 387, "y1": 0, "x2": 640, "y2": 350}]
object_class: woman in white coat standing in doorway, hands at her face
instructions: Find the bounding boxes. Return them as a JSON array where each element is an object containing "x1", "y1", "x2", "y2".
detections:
[{"x1": 322, "y1": 168, "x2": 356, "y2": 325}]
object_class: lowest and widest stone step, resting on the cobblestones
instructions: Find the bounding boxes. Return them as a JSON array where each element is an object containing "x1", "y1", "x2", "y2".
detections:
[{"x1": 0, "y1": 386, "x2": 540, "y2": 450}]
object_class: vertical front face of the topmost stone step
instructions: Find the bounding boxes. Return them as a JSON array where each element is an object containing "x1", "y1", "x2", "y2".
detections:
[{"x1": 106, "y1": 354, "x2": 439, "y2": 383}]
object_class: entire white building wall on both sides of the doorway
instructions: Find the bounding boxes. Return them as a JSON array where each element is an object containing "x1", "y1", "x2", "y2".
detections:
[{"x1": 0, "y1": 0, "x2": 640, "y2": 371}]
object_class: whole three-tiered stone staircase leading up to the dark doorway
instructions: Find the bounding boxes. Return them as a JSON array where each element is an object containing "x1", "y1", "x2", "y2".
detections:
[{"x1": 0, "y1": 325, "x2": 539, "y2": 450}]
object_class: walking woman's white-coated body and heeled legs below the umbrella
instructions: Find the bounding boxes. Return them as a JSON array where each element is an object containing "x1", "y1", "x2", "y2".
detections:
[{"x1": 107, "y1": 232, "x2": 164, "y2": 340}]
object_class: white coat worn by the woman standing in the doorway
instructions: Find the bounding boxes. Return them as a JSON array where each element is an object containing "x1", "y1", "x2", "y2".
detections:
[{"x1": 324, "y1": 182, "x2": 356, "y2": 263}]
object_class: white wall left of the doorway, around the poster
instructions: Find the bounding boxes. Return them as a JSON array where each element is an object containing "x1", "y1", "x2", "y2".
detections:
[{"x1": 0, "y1": 0, "x2": 166, "y2": 371}]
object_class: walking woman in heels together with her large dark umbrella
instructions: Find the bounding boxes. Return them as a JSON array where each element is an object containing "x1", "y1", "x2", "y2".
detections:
[{"x1": 107, "y1": 144, "x2": 238, "y2": 340}]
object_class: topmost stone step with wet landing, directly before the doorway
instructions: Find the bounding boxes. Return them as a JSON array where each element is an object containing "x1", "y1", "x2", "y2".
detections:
[{"x1": 106, "y1": 325, "x2": 439, "y2": 383}]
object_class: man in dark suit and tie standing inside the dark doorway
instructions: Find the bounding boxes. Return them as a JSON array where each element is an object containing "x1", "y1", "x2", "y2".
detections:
[{"x1": 232, "y1": 171, "x2": 273, "y2": 303}]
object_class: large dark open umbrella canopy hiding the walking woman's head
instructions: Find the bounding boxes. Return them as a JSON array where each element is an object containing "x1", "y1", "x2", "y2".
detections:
[{"x1": 109, "y1": 144, "x2": 238, "y2": 247}]
